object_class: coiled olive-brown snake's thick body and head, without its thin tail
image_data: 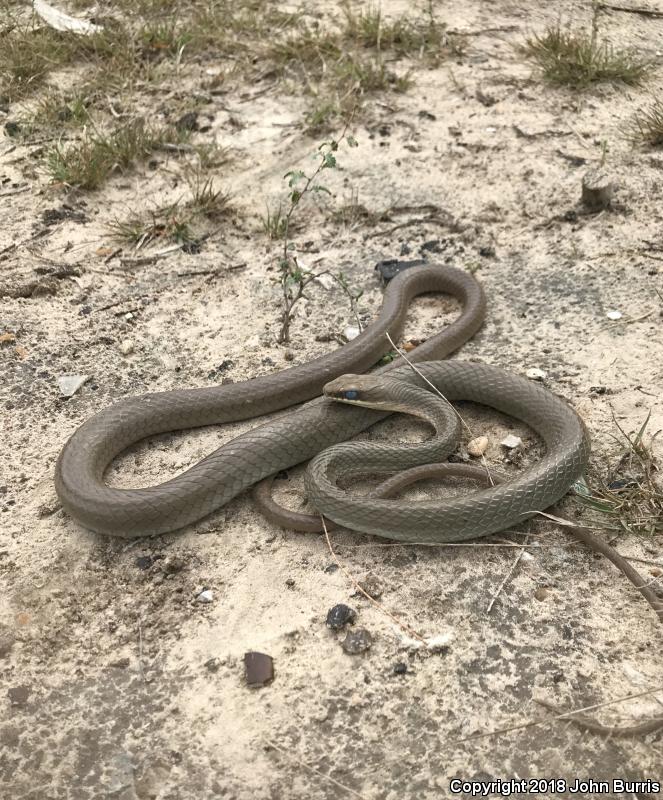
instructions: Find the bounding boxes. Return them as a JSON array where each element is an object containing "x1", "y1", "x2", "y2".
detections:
[{"x1": 55, "y1": 264, "x2": 590, "y2": 542}]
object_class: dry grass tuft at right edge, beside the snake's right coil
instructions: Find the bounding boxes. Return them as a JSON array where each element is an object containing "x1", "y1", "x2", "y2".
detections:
[{"x1": 576, "y1": 412, "x2": 663, "y2": 535}]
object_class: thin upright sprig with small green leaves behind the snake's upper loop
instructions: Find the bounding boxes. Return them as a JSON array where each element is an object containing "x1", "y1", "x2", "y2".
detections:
[{"x1": 278, "y1": 125, "x2": 357, "y2": 344}]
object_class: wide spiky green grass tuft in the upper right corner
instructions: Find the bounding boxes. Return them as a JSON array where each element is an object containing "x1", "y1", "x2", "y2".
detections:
[{"x1": 523, "y1": 11, "x2": 651, "y2": 89}]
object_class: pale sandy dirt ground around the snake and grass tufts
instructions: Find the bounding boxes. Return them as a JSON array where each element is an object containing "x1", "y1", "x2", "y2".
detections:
[{"x1": 0, "y1": 0, "x2": 663, "y2": 800}]
